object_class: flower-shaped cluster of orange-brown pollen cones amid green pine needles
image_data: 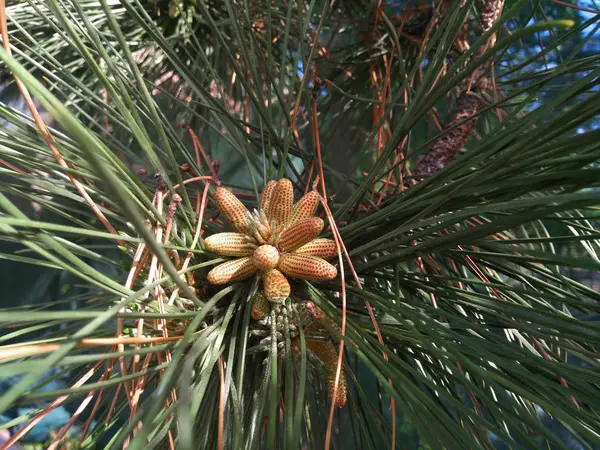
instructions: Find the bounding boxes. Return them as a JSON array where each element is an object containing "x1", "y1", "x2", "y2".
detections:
[{"x1": 205, "y1": 178, "x2": 337, "y2": 303}]
